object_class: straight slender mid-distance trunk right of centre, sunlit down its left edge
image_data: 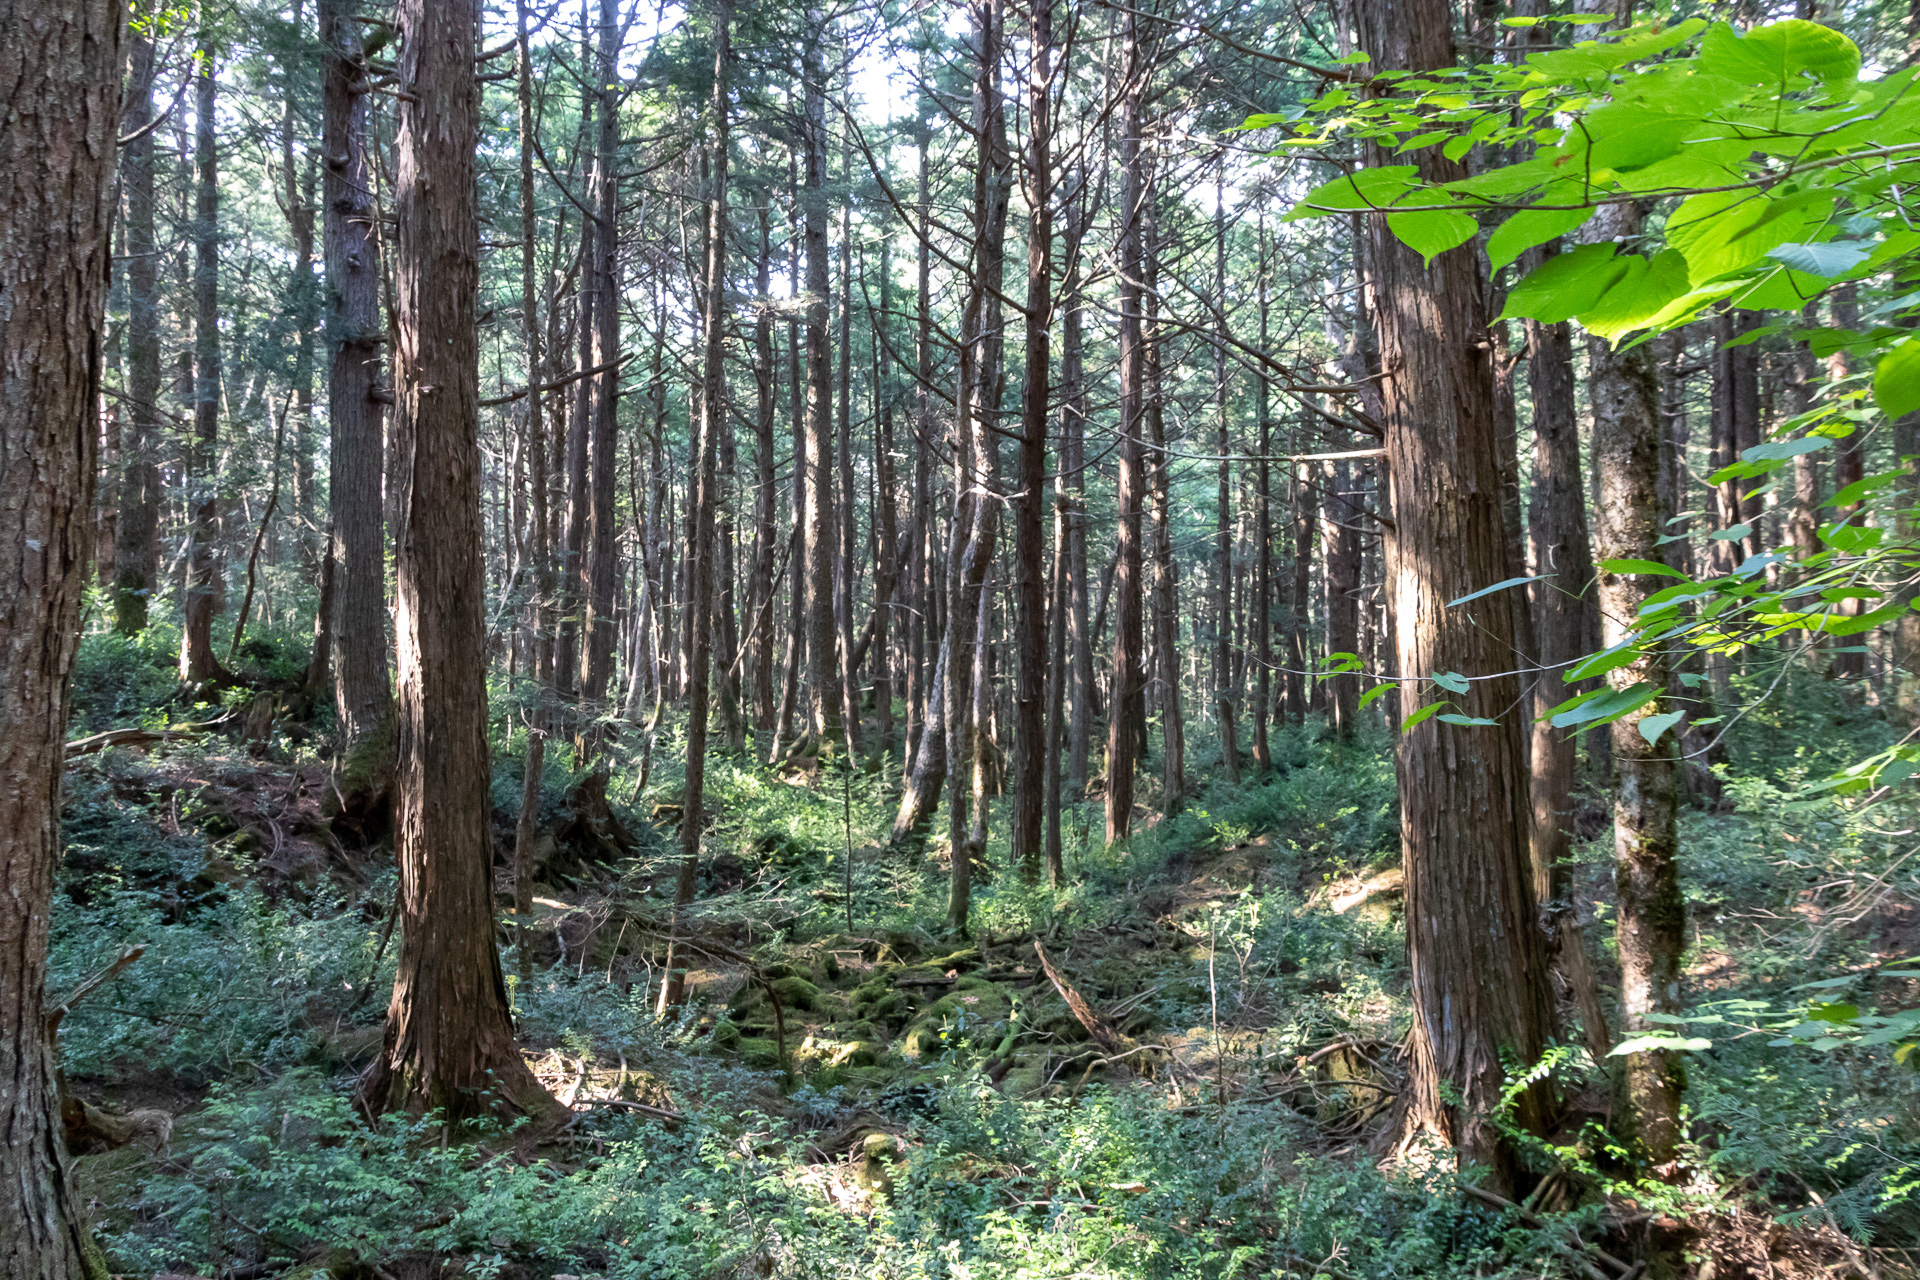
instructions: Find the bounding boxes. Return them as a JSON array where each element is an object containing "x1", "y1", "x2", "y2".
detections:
[{"x1": 1106, "y1": 10, "x2": 1146, "y2": 844}]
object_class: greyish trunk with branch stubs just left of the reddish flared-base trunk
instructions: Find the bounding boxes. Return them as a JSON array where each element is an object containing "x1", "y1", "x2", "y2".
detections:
[{"x1": 319, "y1": 0, "x2": 394, "y2": 829}]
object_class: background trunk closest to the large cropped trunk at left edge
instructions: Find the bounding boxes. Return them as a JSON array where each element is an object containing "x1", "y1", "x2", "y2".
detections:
[{"x1": 113, "y1": 33, "x2": 159, "y2": 635}]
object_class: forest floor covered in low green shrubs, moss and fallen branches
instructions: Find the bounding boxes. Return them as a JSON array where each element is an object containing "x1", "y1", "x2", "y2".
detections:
[{"x1": 41, "y1": 629, "x2": 1920, "y2": 1280}]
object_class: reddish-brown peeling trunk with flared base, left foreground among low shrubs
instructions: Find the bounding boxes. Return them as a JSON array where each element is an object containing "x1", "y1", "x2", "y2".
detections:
[{"x1": 363, "y1": 0, "x2": 555, "y2": 1121}]
